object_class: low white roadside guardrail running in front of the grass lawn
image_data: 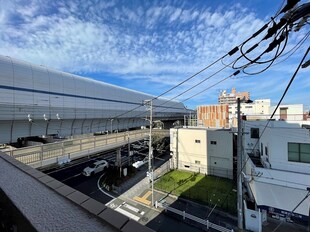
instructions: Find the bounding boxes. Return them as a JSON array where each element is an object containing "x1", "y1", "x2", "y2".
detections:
[{"x1": 155, "y1": 201, "x2": 234, "y2": 232}]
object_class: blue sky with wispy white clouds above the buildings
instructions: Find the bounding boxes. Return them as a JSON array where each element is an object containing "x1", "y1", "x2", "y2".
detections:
[{"x1": 0, "y1": 0, "x2": 310, "y2": 110}]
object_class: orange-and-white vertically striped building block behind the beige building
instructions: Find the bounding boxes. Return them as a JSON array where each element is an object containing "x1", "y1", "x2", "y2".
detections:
[{"x1": 197, "y1": 104, "x2": 229, "y2": 128}]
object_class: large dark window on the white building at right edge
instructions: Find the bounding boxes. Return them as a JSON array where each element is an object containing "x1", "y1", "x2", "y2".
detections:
[{"x1": 288, "y1": 143, "x2": 310, "y2": 163}]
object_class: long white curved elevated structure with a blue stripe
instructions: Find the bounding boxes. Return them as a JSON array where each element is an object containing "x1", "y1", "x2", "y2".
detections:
[{"x1": 0, "y1": 56, "x2": 187, "y2": 144}]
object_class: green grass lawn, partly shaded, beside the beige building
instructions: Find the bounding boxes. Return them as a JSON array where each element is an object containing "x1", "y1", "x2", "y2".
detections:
[{"x1": 154, "y1": 170, "x2": 237, "y2": 213}]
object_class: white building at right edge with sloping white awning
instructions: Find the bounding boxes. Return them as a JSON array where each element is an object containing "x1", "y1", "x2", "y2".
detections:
[{"x1": 243, "y1": 121, "x2": 310, "y2": 227}]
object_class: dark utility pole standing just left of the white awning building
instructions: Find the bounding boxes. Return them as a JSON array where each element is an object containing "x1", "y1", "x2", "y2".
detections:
[{"x1": 237, "y1": 98, "x2": 243, "y2": 230}]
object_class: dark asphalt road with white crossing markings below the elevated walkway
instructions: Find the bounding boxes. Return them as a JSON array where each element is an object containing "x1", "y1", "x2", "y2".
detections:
[{"x1": 44, "y1": 140, "x2": 234, "y2": 232}]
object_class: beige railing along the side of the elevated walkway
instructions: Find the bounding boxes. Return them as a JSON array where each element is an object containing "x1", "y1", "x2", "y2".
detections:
[{"x1": 5, "y1": 130, "x2": 149, "y2": 167}]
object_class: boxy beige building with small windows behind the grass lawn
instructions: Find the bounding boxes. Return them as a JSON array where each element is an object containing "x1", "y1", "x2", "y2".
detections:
[{"x1": 170, "y1": 127, "x2": 233, "y2": 179}]
